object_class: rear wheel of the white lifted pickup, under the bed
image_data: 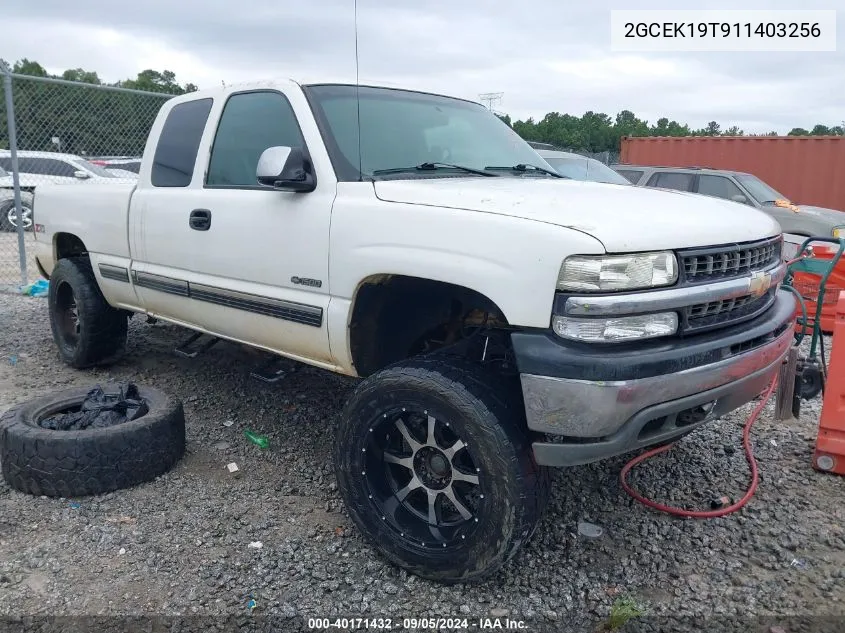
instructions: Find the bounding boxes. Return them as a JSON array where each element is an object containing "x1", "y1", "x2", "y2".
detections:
[{"x1": 47, "y1": 257, "x2": 129, "y2": 369}]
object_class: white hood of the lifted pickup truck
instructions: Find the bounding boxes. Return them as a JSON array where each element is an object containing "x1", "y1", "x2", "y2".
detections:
[{"x1": 373, "y1": 176, "x2": 781, "y2": 253}]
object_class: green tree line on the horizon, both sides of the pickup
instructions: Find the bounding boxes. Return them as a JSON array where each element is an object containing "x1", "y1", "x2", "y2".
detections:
[{"x1": 0, "y1": 59, "x2": 845, "y2": 156}]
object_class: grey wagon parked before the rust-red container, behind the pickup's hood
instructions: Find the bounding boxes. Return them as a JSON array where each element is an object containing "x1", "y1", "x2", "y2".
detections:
[{"x1": 610, "y1": 164, "x2": 845, "y2": 238}]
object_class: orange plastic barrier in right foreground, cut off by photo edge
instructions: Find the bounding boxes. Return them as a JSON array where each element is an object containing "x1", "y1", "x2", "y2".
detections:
[{"x1": 813, "y1": 292, "x2": 845, "y2": 475}]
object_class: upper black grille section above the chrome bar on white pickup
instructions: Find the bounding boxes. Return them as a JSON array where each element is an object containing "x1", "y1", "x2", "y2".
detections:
[{"x1": 681, "y1": 237, "x2": 782, "y2": 282}]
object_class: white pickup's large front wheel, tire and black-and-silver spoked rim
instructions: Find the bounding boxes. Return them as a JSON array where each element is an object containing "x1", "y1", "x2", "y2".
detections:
[{"x1": 334, "y1": 358, "x2": 550, "y2": 582}]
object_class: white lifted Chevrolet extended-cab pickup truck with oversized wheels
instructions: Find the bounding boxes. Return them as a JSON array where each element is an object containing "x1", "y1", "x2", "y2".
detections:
[{"x1": 35, "y1": 81, "x2": 796, "y2": 582}]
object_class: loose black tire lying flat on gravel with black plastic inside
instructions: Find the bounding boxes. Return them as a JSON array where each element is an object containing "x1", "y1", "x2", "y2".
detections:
[{"x1": 0, "y1": 385, "x2": 185, "y2": 497}]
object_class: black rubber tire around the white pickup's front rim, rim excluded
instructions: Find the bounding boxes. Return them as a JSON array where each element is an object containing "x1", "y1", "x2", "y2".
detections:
[{"x1": 334, "y1": 354, "x2": 552, "y2": 583}]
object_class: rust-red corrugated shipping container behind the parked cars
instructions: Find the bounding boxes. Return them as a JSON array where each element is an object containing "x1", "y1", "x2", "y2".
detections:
[{"x1": 620, "y1": 136, "x2": 845, "y2": 211}]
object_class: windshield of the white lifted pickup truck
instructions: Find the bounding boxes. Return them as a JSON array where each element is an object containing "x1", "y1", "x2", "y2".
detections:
[{"x1": 306, "y1": 85, "x2": 550, "y2": 181}]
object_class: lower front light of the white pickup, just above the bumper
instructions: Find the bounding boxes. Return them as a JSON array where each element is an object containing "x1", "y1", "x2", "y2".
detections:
[{"x1": 552, "y1": 312, "x2": 678, "y2": 343}]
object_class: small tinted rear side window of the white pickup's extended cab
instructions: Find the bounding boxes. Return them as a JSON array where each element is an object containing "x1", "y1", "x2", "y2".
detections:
[{"x1": 150, "y1": 98, "x2": 213, "y2": 187}]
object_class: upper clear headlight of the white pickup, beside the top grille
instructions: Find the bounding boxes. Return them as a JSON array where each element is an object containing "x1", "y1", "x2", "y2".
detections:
[{"x1": 557, "y1": 252, "x2": 678, "y2": 292}]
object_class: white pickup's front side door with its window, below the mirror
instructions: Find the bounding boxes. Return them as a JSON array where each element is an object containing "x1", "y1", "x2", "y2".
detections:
[{"x1": 183, "y1": 90, "x2": 336, "y2": 363}]
